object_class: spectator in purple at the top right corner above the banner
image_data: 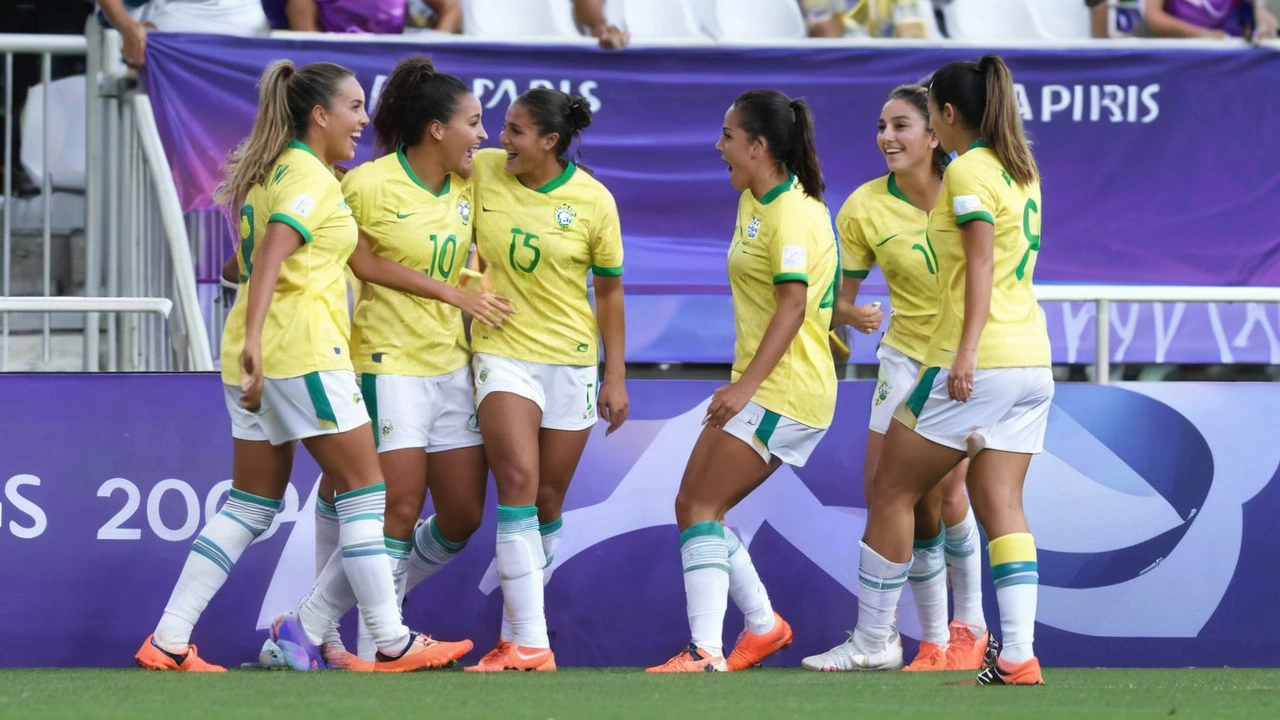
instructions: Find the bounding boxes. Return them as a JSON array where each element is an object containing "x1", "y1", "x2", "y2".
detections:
[{"x1": 1144, "y1": 0, "x2": 1276, "y2": 40}]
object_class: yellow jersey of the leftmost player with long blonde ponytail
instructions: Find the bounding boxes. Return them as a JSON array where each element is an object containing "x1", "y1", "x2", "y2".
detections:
[{"x1": 221, "y1": 140, "x2": 358, "y2": 384}]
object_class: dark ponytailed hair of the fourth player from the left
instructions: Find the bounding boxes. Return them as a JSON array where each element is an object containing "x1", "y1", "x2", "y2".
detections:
[{"x1": 733, "y1": 90, "x2": 827, "y2": 200}]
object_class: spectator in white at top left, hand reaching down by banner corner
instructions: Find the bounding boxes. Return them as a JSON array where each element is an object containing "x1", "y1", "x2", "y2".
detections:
[{"x1": 97, "y1": 0, "x2": 271, "y2": 68}]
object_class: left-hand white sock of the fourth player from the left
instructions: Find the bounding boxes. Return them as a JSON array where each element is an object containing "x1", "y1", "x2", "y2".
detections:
[{"x1": 680, "y1": 520, "x2": 730, "y2": 657}]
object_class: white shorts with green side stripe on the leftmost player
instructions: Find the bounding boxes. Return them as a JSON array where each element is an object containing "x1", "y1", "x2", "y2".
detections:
[{"x1": 223, "y1": 370, "x2": 369, "y2": 445}]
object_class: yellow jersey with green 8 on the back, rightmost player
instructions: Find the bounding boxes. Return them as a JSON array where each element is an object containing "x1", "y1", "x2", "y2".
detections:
[{"x1": 924, "y1": 140, "x2": 1051, "y2": 368}]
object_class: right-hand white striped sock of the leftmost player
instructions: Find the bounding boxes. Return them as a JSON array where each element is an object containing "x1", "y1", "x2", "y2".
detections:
[{"x1": 334, "y1": 483, "x2": 410, "y2": 657}]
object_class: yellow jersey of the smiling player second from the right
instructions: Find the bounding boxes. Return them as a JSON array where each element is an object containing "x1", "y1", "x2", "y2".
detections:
[{"x1": 836, "y1": 173, "x2": 938, "y2": 363}]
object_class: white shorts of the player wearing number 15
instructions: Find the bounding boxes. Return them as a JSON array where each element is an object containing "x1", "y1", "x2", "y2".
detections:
[{"x1": 471, "y1": 352, "x2": 600, "y2": 430}]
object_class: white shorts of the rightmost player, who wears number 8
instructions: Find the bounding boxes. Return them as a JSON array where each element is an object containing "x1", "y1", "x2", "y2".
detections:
[{"x1": 893, "y1": 368, "x2": 1053, "y2": 456}]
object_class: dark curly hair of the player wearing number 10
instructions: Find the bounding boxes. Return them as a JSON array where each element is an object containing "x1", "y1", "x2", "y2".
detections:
[{"x1": 374, "y1": 55, "x2": 471, "y2": 154}]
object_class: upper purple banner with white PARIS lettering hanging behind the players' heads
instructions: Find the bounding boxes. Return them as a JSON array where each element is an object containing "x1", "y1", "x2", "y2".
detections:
[{"x1": 145, "y1": 35, "x2": 1280, "y2": 288}]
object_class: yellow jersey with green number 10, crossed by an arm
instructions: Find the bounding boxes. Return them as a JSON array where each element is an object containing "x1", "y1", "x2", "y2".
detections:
[{"x1": 342, "y1": 150, "x2": 474, "y2": 377}]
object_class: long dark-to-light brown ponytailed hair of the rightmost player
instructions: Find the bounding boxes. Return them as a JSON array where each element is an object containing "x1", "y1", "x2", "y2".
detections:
[{"x1": 929, "y1": 55, "x2": 1039, "y2": 184}]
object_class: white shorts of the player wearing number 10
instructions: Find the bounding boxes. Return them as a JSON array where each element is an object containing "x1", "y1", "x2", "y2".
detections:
[{"x1": 360, "y1": 365, "x2": 480, "y2": 452}]
